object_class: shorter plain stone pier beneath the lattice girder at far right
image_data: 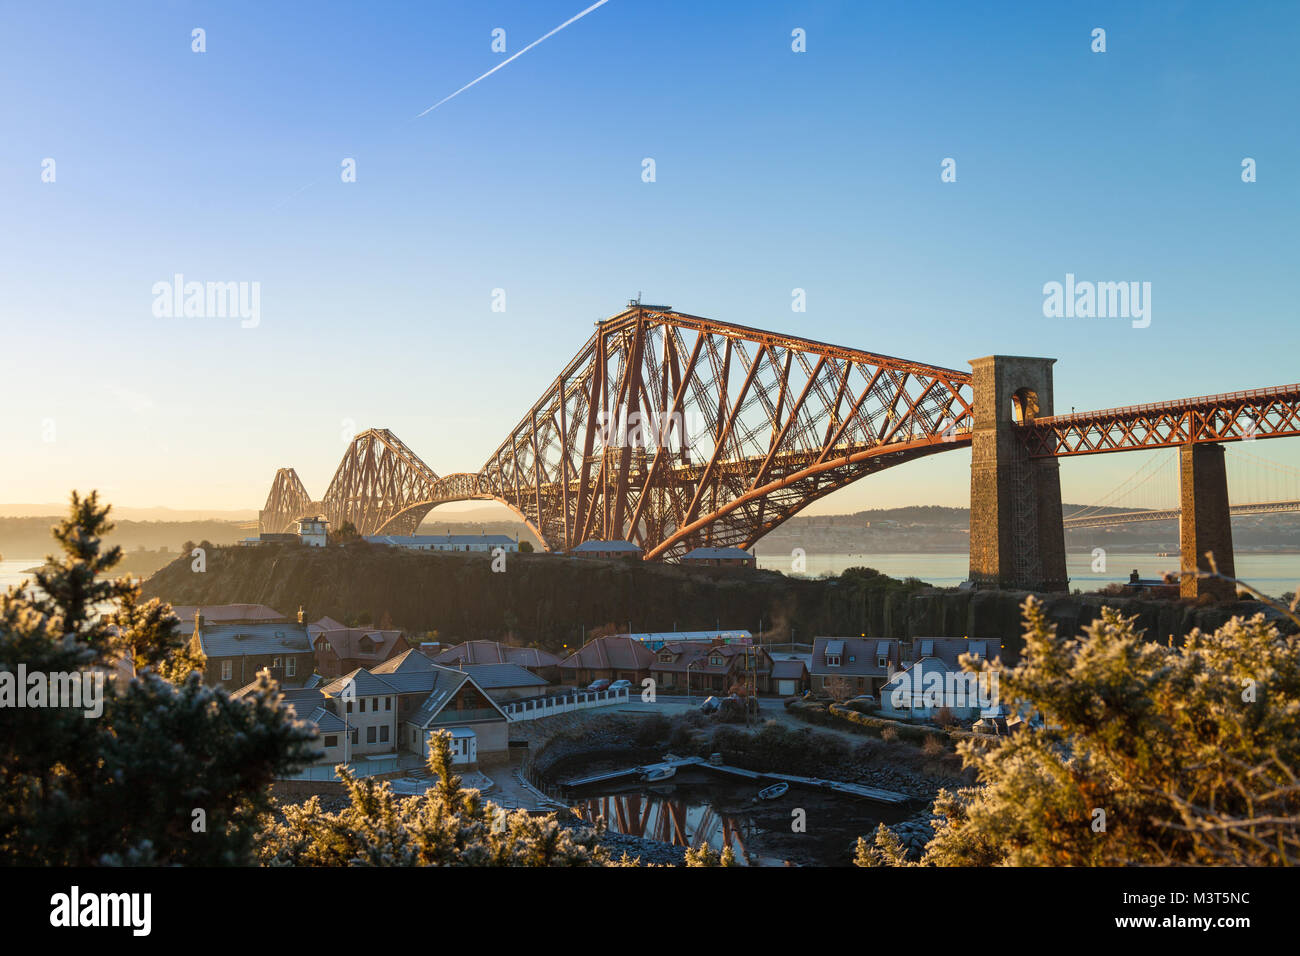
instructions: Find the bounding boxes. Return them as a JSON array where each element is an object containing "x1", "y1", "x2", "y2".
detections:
[{"x1": 1178, "y1": 442, "x2": 1236, "y2": 598}]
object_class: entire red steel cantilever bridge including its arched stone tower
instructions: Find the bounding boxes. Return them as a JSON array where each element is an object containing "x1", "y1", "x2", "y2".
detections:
[{"x1": 259, "y1": 302, "x2": 1300, "y2": 587}]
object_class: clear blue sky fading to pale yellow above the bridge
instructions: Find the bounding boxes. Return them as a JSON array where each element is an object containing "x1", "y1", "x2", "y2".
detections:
[{"x1": 0, "y1": 0, "x2": 1300, "y2": 512}]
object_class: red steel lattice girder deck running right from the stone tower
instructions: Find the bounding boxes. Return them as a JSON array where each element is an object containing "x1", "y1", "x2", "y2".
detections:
[{"x1": 1022, "y1": 385, "x2": 1300, "y2": 458}]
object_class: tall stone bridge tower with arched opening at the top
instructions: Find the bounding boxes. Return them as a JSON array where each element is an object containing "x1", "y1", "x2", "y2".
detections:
[{"x1": 970, "y1": 355, "x2": 1070, "y2": 591}]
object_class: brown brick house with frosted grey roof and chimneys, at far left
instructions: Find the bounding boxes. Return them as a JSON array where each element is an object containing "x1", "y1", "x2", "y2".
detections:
[{"x1": 190, "y1": 610, "x2": 316, "y2": 689}]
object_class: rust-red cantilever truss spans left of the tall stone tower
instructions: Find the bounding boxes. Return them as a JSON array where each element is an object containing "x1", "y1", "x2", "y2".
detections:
[{"x1": 260, "y1": 304, "x2": 972, "y2": 558}]
